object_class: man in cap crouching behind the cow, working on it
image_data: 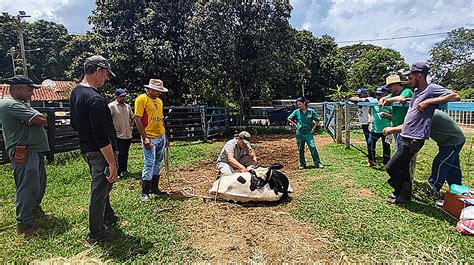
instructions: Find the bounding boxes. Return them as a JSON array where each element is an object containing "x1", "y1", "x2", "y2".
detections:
[{"x1": 217, "y1": 131, "x2": 257, "y2": 176}]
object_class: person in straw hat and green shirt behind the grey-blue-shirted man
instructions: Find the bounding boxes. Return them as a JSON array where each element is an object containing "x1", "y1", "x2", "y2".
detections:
[{"x1": 379, "y1": 74, "x2": 413, "y2": 152}]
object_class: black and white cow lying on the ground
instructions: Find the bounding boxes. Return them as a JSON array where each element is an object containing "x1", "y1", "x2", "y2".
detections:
[{"x1": 209, "y1": 164, "x2": 293, "y2": 202}]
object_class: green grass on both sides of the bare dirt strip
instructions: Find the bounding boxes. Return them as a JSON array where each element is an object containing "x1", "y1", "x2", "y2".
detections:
[{"x1": 0, "y1": 134, "x2": 474, "y2": 263}]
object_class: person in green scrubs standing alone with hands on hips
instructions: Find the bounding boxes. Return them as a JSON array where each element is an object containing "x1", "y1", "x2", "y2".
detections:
[{"x1": 288, "y1": 97, "x2": 324, "y2": 169}]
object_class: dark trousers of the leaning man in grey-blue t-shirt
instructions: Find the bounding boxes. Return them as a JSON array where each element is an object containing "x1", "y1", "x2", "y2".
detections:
[{"x1": 386, "y1": 136, "x2": 424, "y2": 196}]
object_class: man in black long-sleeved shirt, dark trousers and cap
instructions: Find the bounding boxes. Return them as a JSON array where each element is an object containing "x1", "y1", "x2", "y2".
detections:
[{"x1": 70, "y1": 55, "x2": 118, "y2": 243}]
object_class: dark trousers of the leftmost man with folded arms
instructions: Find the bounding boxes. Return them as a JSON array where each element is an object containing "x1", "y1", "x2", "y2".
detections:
[{"x1": 11, "y1": 151, "x2": 46, "y2": 225}]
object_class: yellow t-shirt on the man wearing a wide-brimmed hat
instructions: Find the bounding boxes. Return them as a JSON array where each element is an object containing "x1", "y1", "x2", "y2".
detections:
[{"x1": 135, "y1": 94, "x2": 165, "y2": 138}]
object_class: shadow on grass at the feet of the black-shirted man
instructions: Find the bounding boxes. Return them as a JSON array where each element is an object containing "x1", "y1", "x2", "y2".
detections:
[{"x1": 99, "y1": 227, "x2": 153, "y2": 262}]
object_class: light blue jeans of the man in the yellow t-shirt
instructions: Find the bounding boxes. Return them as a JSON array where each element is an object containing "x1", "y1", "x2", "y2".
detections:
[{"x1": 142, "y1": 134, "x2": 166, "y2": 181}]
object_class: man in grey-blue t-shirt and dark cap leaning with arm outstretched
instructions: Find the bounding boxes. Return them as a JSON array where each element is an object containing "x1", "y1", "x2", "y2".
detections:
[{"x1": 386, "y1": 62, "x2": 461, "y2": 204}]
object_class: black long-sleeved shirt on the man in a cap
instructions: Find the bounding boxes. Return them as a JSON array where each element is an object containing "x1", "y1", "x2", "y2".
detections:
[{"x1": 69, "y1": 85, "x2": 117, "y2": 153}]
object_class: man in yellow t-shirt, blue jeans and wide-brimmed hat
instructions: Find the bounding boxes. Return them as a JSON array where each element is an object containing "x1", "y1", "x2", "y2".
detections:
[{"x1": 135, "y1": 79, "x2": 169, "y2": 202}]
